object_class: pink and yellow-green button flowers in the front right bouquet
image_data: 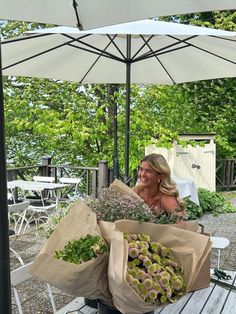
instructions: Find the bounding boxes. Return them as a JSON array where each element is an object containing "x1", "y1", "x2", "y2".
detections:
[{"x1": 124, "y1": 233, "x2": 185, "y2": 305}]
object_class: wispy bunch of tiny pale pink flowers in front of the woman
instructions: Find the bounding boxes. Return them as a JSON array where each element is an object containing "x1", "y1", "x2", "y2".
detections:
[{"x1": 86, "y1": 189, "x2": 180, "y2": 224}]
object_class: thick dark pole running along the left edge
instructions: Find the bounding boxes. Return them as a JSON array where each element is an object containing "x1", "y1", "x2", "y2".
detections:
[{"x1": 0, "y1": 38, "x2": 11, "y2": 314}]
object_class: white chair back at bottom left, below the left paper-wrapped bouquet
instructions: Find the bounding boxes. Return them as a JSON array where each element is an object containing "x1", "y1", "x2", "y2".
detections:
[{"x1": 11, "y1": 262, "x2": 56, "y2": 314}]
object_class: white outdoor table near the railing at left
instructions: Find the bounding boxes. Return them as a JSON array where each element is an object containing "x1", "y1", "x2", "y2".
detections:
[{"x1": 7, "y1": 180, "x2": 69, "y2": 207}]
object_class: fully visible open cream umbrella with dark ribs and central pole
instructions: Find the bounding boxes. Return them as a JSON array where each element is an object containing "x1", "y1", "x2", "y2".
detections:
[{"x1": 2, "y1": 20, "x2": 236, "y2": 179}]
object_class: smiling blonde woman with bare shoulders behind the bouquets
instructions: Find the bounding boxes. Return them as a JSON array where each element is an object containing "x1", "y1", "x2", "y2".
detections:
[{"x1": 133, "y1": 154, "x2": 185, "y2": 217}]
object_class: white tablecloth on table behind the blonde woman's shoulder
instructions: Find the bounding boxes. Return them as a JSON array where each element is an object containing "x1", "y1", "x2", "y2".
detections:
[{"x1": 172, "y1": 177, "x2": 199, "y2": 205}]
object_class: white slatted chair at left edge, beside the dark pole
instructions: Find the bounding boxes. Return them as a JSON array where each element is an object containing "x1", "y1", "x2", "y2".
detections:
[{"x1": 8, "y1": 202, "x2": 29, "y2": 265}]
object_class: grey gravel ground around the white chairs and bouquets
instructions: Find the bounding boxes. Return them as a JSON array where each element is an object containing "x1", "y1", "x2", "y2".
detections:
[{"x1": 11, "y1": 200, "x2": 236, "y2": 314}]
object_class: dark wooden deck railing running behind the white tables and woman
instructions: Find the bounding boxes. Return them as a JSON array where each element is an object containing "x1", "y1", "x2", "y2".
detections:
[{"x1": 7, "y1": 157, "x2": 236, "y2": 196}]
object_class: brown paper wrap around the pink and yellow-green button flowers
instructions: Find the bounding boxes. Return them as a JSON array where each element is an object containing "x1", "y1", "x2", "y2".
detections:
[{"x1": 103, "y1": 220, "x2": 211, "y2": 314}]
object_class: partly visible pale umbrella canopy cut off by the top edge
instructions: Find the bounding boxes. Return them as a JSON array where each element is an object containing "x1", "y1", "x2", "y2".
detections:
[{"x1": 0, "y1": 0, "x2": 236, "y2": 29}]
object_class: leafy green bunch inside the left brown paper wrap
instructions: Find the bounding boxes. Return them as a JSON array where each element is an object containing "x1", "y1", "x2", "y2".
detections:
[{"x1": 55, "y1": 234, "x2": 108, "y2": 264}]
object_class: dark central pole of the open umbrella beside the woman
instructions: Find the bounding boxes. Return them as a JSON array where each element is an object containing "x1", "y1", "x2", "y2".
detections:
[{"x1": 124, "y1": 35, "x2": 131, "y2": 184}]
